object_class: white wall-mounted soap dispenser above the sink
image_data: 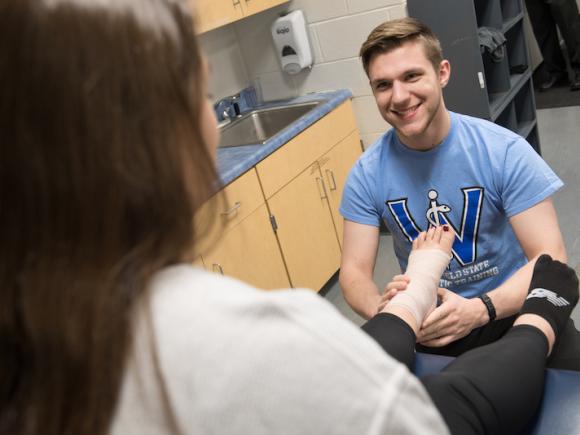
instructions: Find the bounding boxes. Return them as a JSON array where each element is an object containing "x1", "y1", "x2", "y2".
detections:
[{"x1": 272, "y1": 10, "x2": 312, "y2": 74}]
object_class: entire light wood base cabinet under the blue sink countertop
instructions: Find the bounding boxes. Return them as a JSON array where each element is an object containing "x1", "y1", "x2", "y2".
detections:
[{"x1": 196, "y1": 99, "x2": 362, "y2": 290}]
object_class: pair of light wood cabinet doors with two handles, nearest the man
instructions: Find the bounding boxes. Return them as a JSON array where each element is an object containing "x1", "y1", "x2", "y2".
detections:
[{"x1": 268, "y1": 131, "x2": 361, "y2": 290}]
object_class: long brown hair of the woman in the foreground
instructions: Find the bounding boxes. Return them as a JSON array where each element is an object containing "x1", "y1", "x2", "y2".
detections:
[{"x1": 0, "y1": 0, "x2": 216, "y2": 435}]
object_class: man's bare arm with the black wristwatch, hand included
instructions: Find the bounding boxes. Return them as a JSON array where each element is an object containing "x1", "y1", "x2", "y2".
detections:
[{"x1": 417, "y1": 198, "x2": 567, "y2": 347}]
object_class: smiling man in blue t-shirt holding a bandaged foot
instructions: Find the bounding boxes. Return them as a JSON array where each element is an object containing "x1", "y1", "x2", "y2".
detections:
[{"x1": 340, "y1": 18, "x2": 567, "y2": 362}]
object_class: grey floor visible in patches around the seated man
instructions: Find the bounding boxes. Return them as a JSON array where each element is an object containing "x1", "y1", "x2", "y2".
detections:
[{"x1": 321, "y1": 106, "x2": 580, "y2": 327}]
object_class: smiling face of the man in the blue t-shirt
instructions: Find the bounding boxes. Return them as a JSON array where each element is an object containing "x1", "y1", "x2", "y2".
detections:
[{"x1": 369, "y1": 42, "x2": 450, "y2": 149}]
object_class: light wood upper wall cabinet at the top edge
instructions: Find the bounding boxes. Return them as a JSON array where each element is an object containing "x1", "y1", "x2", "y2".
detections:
[{"x1": 190, "y1": 0, "x2": 288, "y2": 33}]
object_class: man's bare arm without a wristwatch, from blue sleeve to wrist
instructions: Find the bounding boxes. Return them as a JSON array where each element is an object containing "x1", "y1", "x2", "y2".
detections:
[{"x1": 339, "y1": 219, "x2": 381, "y2": 320}]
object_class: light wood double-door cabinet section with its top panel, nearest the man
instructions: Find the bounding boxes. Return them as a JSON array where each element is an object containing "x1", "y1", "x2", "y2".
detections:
[{"x1": 256, "y1": 101, "x2": 362, "y2": 290}]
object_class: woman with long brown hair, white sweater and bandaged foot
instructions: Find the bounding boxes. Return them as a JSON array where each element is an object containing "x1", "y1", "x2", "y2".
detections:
[{"x1": 0, "y1": 0, "x2": 578, "y2": 435}]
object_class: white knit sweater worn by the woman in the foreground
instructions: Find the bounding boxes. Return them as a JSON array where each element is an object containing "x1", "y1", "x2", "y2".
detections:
[{"x1": 111, "y1": 265, "x2": 447, "y2": 435}]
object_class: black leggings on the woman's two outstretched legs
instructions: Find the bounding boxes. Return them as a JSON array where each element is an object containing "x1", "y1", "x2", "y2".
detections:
[{"x1": 362, "y1": 313, "x2": 548, "y2": 435}]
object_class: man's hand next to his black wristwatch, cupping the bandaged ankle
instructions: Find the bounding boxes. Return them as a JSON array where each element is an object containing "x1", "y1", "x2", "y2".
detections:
[{"x1": 417, "y1": 288, "x2": 489, "y2": 347}]
